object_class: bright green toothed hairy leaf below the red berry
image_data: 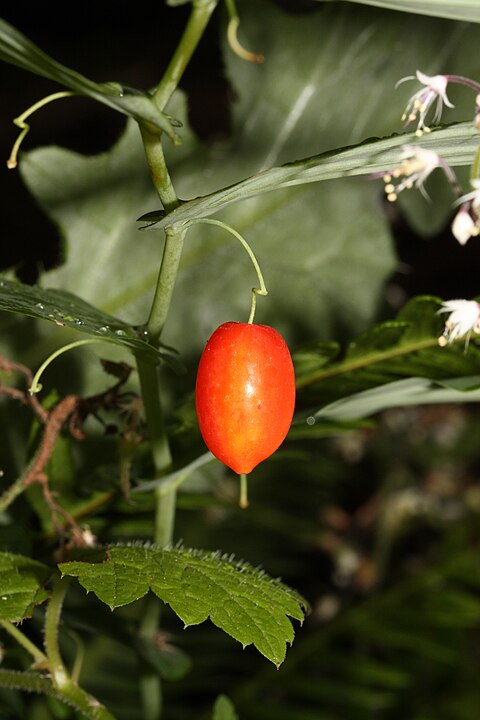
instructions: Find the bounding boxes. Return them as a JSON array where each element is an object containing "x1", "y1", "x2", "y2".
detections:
[{"x1": 59, "y1": 547, "x2": 306, "y2": 665}]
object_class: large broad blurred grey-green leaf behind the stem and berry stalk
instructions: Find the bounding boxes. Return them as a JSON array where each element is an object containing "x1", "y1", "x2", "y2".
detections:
[{"x1": 15, "y1": 2, "x2": 480, "y2": 362}]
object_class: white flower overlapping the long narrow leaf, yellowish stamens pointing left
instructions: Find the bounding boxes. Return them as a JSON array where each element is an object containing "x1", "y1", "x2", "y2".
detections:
[{"x1": 373, "y1": 145, "x2": 450, "y2": 202}]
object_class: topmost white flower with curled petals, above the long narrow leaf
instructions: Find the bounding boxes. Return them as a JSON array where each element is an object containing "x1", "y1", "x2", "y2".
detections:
[{"x1": 395, "y1": 70, "x2": 454, "y2": 136}]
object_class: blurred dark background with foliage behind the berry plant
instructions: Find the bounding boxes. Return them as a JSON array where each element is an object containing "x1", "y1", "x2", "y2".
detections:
[{"x1": 0, "y1": 0, "x2": 480, "y2": 720}]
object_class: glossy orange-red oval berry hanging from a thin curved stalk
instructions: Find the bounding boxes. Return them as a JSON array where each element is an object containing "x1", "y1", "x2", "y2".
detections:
[{"x1": 196, "y1": 322, "x2": 295, "y2": 474}]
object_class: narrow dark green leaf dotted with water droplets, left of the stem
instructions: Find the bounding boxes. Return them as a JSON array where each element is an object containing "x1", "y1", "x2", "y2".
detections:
[{"x1": 0, "y1": 279, "x2": 162, "y2": 360}]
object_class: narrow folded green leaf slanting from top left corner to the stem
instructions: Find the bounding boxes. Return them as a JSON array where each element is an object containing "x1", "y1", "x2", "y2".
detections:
[{"x1": 0, "y1": 19, "x2": 179, "y2": 142}]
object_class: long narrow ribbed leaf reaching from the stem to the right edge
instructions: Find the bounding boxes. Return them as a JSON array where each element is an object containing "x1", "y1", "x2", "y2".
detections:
[{"x1": 139, "y1": 123, "x2": 478, "y2": 230}]
